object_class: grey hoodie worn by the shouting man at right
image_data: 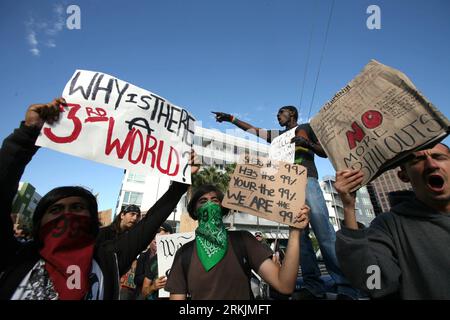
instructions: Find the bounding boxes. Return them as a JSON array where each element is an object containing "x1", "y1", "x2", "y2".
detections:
[{"x1": 336, "y1": 198, "x2": 450, "y2": 299}]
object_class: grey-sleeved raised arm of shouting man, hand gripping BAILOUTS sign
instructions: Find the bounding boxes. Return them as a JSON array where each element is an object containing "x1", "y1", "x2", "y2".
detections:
[{"x1": 335, "y1": 170, "x2": 401, "y2": 298}]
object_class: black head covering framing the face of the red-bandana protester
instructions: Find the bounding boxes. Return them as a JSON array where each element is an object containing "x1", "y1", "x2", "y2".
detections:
[{"x1": 33, "y1": 186, "x2": 100, "y2": 240}]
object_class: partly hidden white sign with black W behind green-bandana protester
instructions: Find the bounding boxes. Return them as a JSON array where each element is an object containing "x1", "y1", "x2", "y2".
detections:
[{"x1": 155, "y1": 232, "x2": 195, "y2": 298}]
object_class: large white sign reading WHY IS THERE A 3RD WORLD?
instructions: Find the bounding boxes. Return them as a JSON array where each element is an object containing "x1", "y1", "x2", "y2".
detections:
[{"x1": 36, "y1": 70, "x2": 195, "y2": 183}]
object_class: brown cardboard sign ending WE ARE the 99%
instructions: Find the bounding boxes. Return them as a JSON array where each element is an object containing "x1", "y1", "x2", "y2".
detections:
[{"x1": 222, "y1": 156, "x2": 307, "y2": 226}]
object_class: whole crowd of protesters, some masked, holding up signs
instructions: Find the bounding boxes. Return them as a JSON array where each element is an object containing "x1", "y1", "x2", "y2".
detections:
[{"x1": 0, "y1": 98, "x2": 450, "y2": 300}]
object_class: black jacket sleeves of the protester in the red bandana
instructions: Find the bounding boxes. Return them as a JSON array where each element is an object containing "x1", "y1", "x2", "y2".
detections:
[{"x1": 0, "y1": 123, "x2": 188, "y2": 299}]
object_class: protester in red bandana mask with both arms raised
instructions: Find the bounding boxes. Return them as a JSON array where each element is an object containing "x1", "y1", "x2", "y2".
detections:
[{"x1": 0, "y1": 98, "x2": 198, "y2": 300}]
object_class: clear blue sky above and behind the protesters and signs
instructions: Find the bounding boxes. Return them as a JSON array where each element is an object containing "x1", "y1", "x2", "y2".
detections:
[{"x1": 0, "y1": 0, "x2": 450, "y2": 209}]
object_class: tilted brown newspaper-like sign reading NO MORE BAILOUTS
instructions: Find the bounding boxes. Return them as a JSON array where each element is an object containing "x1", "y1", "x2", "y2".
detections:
[{"x1": 310, "y1": 60, "x2": 450, "y2": 185}]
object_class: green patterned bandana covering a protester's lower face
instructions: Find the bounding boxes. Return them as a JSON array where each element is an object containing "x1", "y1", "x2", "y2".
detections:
[{"x1": 195, "y1": 201, "x2": 228, "y2": 271}]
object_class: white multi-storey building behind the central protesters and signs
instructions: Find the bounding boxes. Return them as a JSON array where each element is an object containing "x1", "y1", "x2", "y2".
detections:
[{"x1": 115, "y1": 127, "x2": 288, "y2": 238}]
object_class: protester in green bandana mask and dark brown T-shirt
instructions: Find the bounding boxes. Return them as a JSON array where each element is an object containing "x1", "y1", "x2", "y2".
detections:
[{"x1": 165, "y1": 185, "x2": 309, "y2": 300}]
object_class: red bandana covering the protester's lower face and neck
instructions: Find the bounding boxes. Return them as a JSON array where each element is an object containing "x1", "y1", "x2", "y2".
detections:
[{"x1": 39, "y1": 213, "x2": 95, "y2": 300}]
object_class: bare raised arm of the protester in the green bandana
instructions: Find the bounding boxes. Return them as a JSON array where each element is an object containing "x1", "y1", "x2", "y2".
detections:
[{"x1": 258, "y1": 205, "x2": 310, "y2": 294}]
